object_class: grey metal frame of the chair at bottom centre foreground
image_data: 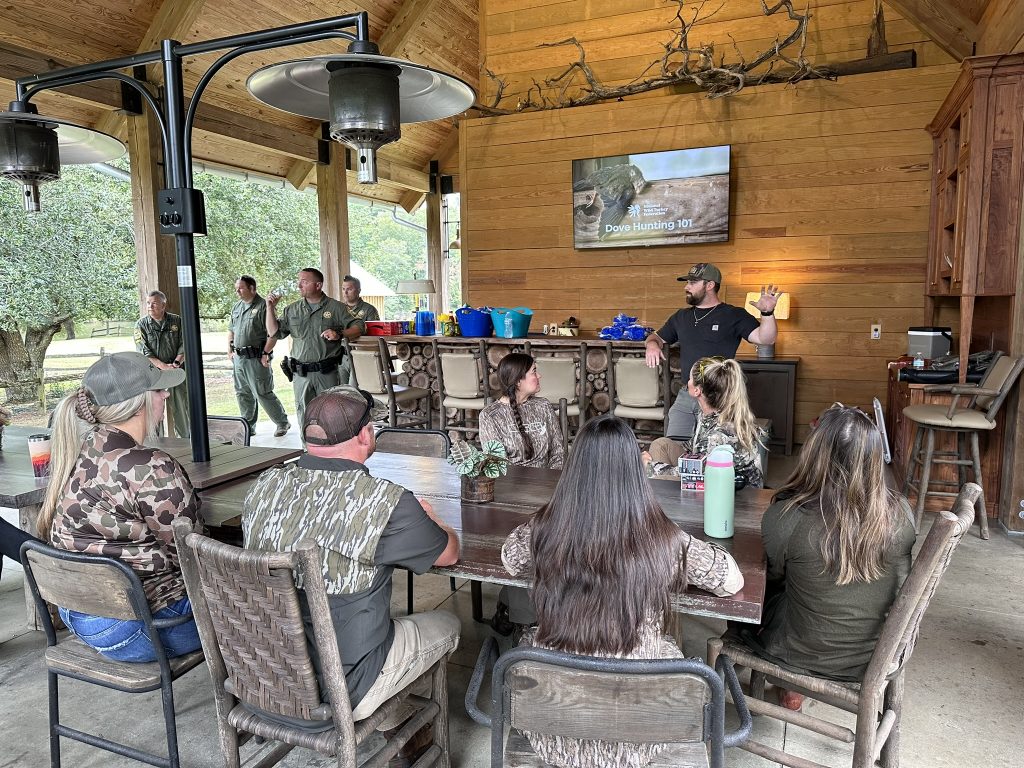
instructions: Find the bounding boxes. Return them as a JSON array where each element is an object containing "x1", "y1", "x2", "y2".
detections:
[{"x1": 466, "y1": 637, "x2": 752, "y2": 768}]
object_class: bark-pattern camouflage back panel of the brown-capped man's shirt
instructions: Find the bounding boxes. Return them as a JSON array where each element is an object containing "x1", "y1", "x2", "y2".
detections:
[{"x1": 242, "y1": 464, "x2": 404, "y2": 595}]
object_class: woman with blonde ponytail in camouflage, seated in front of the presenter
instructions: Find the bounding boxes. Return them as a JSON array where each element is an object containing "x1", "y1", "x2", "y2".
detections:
[{"x1": 644, "y1": 357, "x2": 764, "y2": 488}]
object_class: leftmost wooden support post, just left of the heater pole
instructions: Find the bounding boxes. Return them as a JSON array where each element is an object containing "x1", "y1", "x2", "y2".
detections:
[{"x1": 127, "y1": 110, "x2": 181, "y2": 315}]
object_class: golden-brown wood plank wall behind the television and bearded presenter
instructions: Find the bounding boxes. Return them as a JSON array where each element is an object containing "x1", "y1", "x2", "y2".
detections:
[{"x1": 460, "y1": 0, "x2": 957, "y2": 441}]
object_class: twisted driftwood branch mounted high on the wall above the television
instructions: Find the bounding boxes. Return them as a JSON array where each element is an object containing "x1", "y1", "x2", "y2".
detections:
[{"x1": 477, "y1": 0, "x2": 836, "y2": 115}]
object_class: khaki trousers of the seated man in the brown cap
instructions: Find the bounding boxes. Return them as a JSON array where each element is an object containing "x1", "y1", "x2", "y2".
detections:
[{"x1": 352, "y1": 610, "x2": 462, "y2": 730}]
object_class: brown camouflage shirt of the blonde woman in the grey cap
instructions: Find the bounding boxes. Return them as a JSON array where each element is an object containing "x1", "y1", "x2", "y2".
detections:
[{"x1": 50, "y1": 425, "x2": 201, "y2": 611}]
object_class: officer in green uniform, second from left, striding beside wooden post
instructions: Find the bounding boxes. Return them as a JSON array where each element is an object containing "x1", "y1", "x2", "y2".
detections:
[{"x1": 227, "y1": 274, "x2": 291, "y2": 437}]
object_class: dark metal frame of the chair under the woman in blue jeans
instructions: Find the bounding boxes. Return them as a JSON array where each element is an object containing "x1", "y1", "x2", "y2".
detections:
[{"x1": 22, "y1": 541, "x2": 203, "y2": 768}]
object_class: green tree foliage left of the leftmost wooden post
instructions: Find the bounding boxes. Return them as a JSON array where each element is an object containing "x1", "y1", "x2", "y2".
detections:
[{"x1": 0, "y1": 167, "x2": 137, "y2": 330}]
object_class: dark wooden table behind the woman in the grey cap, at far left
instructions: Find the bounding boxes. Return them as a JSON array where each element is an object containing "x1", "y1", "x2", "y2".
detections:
[{"x1": 0, "y1": 427, "x2": 302, "y2": 629}]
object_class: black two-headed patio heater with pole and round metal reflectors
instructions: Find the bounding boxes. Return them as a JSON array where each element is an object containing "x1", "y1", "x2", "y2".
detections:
[{"x1": 0, "y1": 11, "x2": 475, "y2": 462}]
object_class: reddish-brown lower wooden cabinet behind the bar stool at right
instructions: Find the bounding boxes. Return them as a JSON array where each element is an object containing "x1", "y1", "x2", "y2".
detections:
[{"x1": 886, "y1": 364, "x2": 1007, "y2": 517}]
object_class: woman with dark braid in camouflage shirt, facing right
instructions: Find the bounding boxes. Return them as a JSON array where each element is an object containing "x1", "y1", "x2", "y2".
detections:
[{"x1": 480, "y1": 352, "x2": 565, "y2": 469}]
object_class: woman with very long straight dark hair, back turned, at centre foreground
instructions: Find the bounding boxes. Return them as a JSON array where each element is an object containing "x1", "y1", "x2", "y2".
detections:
[{"x1": 502, "y1": 415, "x2": 743, "y2": 768}]
